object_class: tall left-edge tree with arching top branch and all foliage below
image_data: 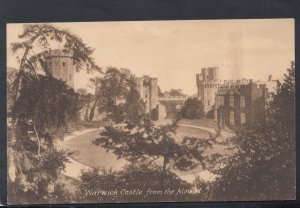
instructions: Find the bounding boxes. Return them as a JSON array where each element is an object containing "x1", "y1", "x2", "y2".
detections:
[{"x1": 8, "y1": 24, "x2": 101, "y2": 203}]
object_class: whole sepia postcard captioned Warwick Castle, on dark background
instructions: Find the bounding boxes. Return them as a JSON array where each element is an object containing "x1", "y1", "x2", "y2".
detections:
[{"x1": 6, "y1": 19, "x2": 296, "y2": 205}]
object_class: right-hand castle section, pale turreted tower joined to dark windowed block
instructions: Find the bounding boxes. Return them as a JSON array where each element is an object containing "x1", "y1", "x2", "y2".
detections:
[{"x1": 196, "y1": 67, "x2": 277, "y2": 129}]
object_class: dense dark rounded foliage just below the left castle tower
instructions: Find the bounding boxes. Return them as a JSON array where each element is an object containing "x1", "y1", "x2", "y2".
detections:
[{"x1": 13, "y1": 75, "x2": 79, "y2": 133}]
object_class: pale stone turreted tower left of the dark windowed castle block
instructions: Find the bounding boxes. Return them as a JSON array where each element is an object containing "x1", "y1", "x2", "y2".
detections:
[{"x1": 196, "y1": 67, "x2": 222, "y2": 113}]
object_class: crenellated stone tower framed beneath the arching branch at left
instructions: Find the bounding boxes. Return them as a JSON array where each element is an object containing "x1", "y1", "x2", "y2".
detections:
[{"x1": 46, "y1": 49, "x2": 75, "y2": 88}]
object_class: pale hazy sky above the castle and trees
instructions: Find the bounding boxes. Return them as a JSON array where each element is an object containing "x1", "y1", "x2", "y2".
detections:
[{"x1": 7, "y1": 19, "x2": 295, "y2": 95}]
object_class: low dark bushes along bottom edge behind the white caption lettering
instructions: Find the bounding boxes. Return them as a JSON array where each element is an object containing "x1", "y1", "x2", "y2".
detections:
[{"x1": 80, "y1": 164, "x2": 191, "y2": 202}]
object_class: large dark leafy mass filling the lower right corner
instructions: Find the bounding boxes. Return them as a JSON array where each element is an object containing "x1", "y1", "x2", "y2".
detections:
[{"x1": 212, "y1": 63, "x2": 296, "y2": 200}]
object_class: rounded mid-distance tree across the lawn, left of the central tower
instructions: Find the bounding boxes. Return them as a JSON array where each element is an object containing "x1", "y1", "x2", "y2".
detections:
[{"x1": 98, "y1": 67, "x2": 144, "y2": 125}]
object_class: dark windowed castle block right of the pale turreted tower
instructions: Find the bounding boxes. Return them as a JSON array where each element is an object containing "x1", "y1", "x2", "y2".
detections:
[{"x1": 214, "y1": 77, "x2": 277, "y2": 129}]
